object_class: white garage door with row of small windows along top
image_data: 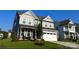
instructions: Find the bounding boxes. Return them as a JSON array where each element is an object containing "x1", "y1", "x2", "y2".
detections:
[{"x1": 43, "y1": 32, "x2": 57, "y2": 41}]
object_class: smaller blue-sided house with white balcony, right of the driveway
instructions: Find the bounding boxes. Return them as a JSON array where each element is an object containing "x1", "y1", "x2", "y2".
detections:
[{"x1": 58, "y1": 19, "x2": 77, "y2": 40}]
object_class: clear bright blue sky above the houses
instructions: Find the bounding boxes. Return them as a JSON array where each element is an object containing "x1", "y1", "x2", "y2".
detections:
[{"x1": 0, "y1": 10, "x2": 79, "y2": 31}]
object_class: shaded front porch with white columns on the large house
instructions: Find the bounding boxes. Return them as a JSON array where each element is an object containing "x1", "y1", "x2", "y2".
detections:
[{"x1": 19, "y1": 28, "x2": 37, "y2": 40}]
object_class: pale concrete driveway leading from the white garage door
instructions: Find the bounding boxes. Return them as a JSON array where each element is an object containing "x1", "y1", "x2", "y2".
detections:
[{"x1": 53, "y1": 41, "x2": 79, "y2": 48}]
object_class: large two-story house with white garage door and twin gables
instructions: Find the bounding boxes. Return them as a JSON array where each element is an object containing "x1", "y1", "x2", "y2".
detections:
[{"x1": 13, "y1": 11, "x2": 58, "y2": 41}]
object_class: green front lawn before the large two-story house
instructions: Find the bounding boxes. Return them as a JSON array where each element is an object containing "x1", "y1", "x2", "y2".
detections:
[{"x1": 0, "y1": 39, "x2": 69, "y2": 49}]
